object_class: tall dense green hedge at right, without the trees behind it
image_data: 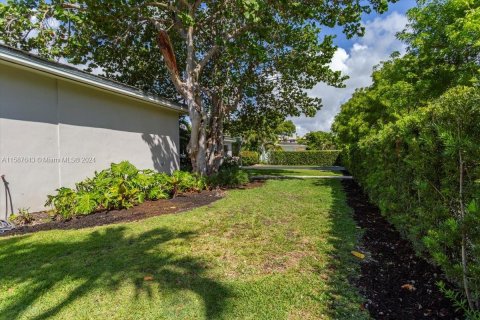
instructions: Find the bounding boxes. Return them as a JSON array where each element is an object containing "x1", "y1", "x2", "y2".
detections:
[{"x1": 344, "y1": 87, "x2": 480, "y2": 319}]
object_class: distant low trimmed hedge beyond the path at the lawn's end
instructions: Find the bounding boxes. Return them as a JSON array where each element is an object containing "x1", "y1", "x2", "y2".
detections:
[{"x1": 268, "y1": 150, "x2": 340, "y2": 167}]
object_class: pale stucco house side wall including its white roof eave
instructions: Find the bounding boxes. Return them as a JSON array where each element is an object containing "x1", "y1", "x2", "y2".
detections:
[{"x1": 0, "y1": 45, "x2": 185, "y2": 219}]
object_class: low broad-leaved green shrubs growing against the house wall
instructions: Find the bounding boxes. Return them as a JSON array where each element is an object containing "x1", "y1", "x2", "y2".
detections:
[{"x1": 45, "y1": 161, "x2": 206, "y2": 219}]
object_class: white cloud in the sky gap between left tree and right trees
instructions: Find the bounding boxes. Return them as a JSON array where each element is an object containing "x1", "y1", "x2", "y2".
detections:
[{"x1": 292, "y1": 12, "x2": 407, "y2": 135}]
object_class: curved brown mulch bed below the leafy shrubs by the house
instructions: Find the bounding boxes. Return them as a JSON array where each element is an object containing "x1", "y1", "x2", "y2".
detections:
[{"x1": 0, "y1": 182, "x2": 263, "y2": 237}]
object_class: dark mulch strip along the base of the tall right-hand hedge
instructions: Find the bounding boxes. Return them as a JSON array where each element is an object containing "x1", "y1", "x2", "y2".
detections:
[{"x1": 342, "y1": 180, "x2": 464, "y2": 320}]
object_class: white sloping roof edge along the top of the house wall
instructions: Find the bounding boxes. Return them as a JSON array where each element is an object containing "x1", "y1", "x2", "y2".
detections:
[{"x1": 0, "y1": 44, "x2": 187, "y2": 113}]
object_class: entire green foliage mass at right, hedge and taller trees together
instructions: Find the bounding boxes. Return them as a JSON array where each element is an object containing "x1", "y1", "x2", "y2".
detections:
[{"x1": 332, "y1": 0, "x2": 480, "y2": 310}]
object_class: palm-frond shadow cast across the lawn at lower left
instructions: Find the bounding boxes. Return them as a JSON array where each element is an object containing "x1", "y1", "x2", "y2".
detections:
[{"x1": 0, "y1": 227, "x2": 230, "y2": 320}]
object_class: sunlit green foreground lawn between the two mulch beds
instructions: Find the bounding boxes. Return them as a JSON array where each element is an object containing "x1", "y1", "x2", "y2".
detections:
[{"x1": 0, "y1": 179, "x2": 368, "y2": 320}]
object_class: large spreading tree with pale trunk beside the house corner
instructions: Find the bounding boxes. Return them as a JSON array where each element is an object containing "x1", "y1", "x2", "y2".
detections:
[{"x1": 0, "y1": 0, "x2": 394, "y2": 174}]
